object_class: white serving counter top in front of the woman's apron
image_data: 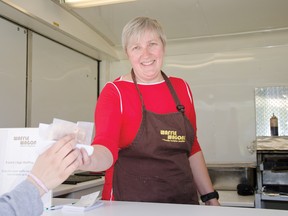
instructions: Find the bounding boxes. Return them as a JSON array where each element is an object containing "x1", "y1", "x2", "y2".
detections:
[{"x1": 43, "y1": 201, "x2": 287, "y2": 216}]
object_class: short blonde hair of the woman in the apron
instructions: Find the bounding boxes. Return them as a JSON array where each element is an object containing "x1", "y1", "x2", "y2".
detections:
[{"x1": 122, "y1": 17, "x2": 166, "y2": 52}]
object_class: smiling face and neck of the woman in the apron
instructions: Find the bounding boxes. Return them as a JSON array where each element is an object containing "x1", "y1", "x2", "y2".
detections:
[{"x1": 126, "y1": 31, "x2": 164, "y2": 82}]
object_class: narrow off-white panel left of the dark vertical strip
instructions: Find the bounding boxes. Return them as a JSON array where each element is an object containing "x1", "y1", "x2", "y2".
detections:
[{"x1": 0, "y1": 18, "x2": 27, "y2": 128}]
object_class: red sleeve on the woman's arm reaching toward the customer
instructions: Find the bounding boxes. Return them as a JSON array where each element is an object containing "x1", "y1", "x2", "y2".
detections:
[{"x1": 92, "y1": 83, "x2": 121, "y2": 161}]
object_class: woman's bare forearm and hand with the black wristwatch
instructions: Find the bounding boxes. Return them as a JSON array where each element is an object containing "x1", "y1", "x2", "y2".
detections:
[{"x1": 189, "y1": 151, "x2": 219, "y2": 205}]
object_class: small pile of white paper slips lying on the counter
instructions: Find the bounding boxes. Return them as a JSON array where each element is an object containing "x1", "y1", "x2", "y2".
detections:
[{"x1": 62, "y1": 191, "x2": 103, "y2": 212}]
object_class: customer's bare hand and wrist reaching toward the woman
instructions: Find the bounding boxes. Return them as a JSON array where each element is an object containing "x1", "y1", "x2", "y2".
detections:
[{"x1": 28, "y1": 135, "x2": 82, "y2": 195}]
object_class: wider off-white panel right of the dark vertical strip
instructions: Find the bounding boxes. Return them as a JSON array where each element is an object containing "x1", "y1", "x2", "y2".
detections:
[{"x1": 28, "y1": 33, "x2": 98, "y2": 127}]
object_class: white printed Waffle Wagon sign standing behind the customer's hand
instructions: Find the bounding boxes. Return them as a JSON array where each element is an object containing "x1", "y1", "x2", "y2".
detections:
[{"x1": 0, "y1": 128, "x2": 52, "y2": 207}]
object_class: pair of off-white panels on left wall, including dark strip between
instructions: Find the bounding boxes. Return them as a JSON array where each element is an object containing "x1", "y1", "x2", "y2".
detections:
[{"x1": 0, "y1": 17, "x2": 98, "y2": 127}]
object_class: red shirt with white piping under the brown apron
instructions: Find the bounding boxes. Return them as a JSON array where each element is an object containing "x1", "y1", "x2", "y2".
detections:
[{"x1": 93, "y1": 77, "x2": 201, "y2": 199}]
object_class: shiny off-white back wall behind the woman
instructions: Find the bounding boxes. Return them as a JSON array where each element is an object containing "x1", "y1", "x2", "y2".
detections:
[{"x1": 110, "y1": 32, "x2": 288, "y2": 163}]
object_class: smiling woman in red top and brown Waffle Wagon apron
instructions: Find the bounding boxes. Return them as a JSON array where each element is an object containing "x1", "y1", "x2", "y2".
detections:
[{"x1": 82, "y1": 17, "x2": 219, "y2": 205}]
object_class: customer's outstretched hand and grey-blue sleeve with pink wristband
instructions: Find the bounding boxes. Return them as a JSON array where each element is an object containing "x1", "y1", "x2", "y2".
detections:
[{"x1": 0, "y1": 135, "x2": 82, "y2": 216}]
